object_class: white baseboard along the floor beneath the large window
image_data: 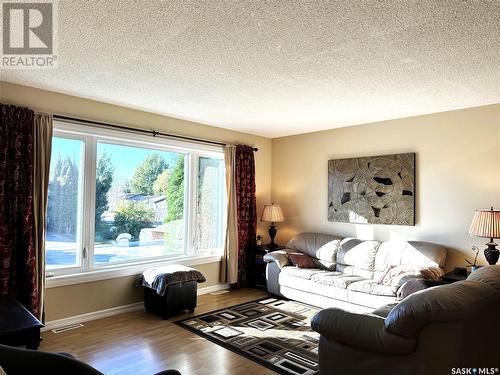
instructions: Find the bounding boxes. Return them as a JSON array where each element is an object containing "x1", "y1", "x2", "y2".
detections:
[{"x1": 42, "y1": 284, "x2": 229, "y2": 332}]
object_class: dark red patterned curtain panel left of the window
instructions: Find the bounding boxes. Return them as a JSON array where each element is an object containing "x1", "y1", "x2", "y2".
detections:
[{"x1": 0, "y1": 104, "x2": 39, "y2": 315}]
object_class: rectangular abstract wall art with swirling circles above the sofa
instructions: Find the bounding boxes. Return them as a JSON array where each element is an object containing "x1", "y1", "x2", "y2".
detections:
[{"x1": 328, "y1": 153, "x2": 415, "y2": 225}]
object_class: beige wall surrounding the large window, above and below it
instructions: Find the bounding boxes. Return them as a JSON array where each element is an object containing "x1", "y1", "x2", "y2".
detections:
[{"x1": 0, "y1": 82, "x2": 271, "y2": 321}]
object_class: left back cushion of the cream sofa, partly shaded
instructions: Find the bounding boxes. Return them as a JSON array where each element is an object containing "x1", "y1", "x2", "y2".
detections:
[{"x1": 286, "y1": 233, "x2": 342, "y2": 270}]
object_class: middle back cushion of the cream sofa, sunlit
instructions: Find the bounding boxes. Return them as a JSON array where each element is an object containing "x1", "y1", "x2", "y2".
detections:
[{"x1": 337, "y1": 238, "x2": 380, "y2": 279}]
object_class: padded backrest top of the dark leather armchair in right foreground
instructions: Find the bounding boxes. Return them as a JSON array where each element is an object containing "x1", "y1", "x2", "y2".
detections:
[{"x1": 385, "y1": 280, "x2": 498, "y2": 338}]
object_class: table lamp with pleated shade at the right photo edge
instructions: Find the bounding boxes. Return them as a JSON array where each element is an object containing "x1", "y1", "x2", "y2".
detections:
[{"x1": 469, "y1": 207, "x2": 500, "y2": 265}]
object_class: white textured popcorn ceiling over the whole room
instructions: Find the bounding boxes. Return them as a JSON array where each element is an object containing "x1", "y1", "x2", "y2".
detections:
[{"x1": 1, "y1": 0, "x2": 500, "y2": 137}]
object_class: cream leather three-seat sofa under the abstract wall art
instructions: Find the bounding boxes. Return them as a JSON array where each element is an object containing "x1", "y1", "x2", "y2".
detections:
[{"x1": 264, "y1": 233, "x2": 447, "y2": 312}]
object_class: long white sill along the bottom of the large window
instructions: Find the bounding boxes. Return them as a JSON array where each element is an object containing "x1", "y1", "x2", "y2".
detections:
[{"x1": 45, "y1": 255, "x2": 222, "y2": 288}]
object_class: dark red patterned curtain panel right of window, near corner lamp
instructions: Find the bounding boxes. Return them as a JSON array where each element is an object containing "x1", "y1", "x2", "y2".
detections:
[{"x1": 235, "y1": 145, "x2": 257, "y2": 287}]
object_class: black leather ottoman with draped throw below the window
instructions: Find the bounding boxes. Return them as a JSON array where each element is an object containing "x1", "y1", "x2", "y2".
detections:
[{"x1": 140, "y1": 265, "x2": 206, "y2": 319}]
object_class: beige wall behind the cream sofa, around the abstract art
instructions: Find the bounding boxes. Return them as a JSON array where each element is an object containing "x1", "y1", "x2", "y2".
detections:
[{"x1": 272, "y1": 104, "x2": 500, "y2": 269}]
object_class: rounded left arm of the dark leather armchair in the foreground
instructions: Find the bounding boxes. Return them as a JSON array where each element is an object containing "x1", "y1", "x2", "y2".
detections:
[{"x1": 311, "y1": 308, "x2": 417, "y2": 354}]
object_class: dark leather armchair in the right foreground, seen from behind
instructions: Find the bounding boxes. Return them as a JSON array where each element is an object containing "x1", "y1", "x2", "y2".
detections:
[{"x1": 311, "y1": 265, "x2": 500, "y2": 374}]
